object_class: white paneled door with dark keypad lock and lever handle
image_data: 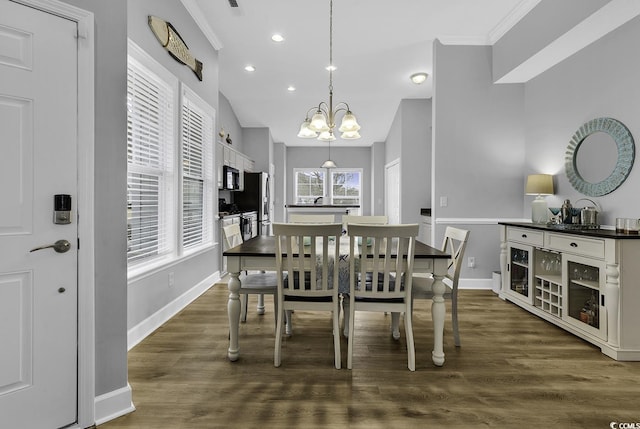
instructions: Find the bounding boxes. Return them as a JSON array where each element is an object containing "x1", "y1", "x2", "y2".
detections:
[{"x1": 0, "y1": 0, "x2": 78, "y2": 428}]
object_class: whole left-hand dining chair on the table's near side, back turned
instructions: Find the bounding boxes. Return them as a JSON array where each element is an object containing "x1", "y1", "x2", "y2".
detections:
[{"x1": 273, "y1": 223, "x2": 342, "y2": 369}]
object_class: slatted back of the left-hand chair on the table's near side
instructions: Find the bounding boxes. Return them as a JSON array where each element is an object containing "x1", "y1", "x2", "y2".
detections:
[{"x1": 273, "y1": 223, "x2": 342, "y2": 297}]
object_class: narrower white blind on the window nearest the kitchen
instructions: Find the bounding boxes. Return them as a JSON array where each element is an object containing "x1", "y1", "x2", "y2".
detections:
[{"x1": 181, "y1": 85, "x2": 214, "y2": 250}]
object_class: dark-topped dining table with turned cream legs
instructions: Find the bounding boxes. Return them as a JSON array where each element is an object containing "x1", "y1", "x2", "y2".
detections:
[{"x1": 223, "y1": 235, "x2": 451, "y2": 366}]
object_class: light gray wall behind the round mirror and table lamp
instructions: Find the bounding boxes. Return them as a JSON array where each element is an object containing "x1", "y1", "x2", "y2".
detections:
[{"x1": 524, "y1": 17, "x2": 640, "y2": 225}]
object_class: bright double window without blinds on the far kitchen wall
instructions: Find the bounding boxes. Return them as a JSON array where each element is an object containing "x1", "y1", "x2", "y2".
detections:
[{"x1": 294, "y1": 168, "x2": 362, "y2": 205}]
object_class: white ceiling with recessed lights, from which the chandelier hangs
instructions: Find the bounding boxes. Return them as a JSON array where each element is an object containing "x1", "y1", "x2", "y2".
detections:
[{"x1": 182, "y1": 0, "x2": 539, "y2": 146}]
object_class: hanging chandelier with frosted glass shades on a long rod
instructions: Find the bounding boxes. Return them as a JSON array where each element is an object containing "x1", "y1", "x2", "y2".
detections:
[{"x1": 298, "y1": 0, "x2": 360, "y2": 147}]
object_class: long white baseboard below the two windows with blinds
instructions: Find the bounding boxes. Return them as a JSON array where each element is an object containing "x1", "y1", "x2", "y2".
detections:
[{"x1": 127, "y1": 271, "x2": 220, "y2": 350}]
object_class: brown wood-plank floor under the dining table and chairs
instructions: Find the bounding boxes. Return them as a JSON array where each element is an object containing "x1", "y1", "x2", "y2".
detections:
[{"x1": 99, "y1": 285, "x2": 640, "y2": 429}]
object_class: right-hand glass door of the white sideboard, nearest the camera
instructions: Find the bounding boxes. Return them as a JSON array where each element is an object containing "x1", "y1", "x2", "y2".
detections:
[{"x1": 566, "y1": 257, "x2": 607, "y2": 339}]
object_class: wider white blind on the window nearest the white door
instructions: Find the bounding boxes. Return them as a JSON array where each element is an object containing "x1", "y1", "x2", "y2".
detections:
[{"x1": 127, "y1": 57, "x2": 175, "y2": 264}]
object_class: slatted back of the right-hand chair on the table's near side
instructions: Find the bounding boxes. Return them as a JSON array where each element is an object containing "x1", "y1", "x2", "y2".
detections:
[{"x1": 349, "y1": 224, "x2": 418, "y2": 299}]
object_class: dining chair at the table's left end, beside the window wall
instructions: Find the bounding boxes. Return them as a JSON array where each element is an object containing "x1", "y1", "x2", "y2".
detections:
[{"x1": 222, "y1": 223, "x2": 278, "y2": 322}]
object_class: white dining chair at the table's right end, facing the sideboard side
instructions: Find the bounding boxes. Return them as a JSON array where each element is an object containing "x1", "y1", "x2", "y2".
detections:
[{"x1": 412, "y1": 226, "x2": 469, "y2": 347}]
